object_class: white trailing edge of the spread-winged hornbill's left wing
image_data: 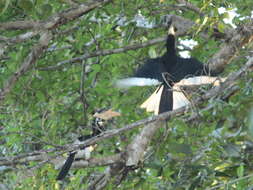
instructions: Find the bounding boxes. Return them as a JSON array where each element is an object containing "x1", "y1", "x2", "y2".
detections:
[{"x1": 115, "y1": 77, "x2": 161, "y2": 88}]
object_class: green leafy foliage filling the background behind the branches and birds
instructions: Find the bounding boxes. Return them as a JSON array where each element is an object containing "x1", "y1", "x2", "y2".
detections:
[{"x1": 0, "y1": 0, "x2": 253, "y2": 189}]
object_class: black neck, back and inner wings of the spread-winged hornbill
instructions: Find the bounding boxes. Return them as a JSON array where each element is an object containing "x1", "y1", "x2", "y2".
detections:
[{"x1": 134, "y1": 25, "x2": 208, "y2": 82}]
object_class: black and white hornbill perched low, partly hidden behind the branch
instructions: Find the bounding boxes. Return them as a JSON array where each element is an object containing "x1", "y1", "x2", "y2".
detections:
[{"x1": 56, "y1": 109, "x2": 120, "y2": 180}]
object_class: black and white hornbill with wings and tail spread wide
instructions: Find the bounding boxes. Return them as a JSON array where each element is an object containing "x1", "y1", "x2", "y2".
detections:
[{"x1": 116, "y1": 24, "x2": 224, "y2": 114}]
